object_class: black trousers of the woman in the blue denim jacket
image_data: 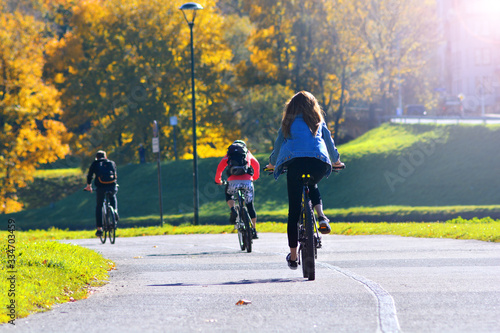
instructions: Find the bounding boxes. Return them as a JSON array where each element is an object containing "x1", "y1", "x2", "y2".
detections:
[{"x1": 286, "y1": 157, "x2": 330, "y2": 248}]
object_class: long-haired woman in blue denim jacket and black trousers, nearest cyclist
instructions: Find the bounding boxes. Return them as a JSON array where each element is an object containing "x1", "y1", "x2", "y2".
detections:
[{"x1": 267, "y1": 91, "x2": 344, "y2": 269}]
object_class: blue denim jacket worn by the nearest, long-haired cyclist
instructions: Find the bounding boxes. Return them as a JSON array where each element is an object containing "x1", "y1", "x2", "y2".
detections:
[{"x1": 269, "y1": 115, "x2": 340, "y2": 179}]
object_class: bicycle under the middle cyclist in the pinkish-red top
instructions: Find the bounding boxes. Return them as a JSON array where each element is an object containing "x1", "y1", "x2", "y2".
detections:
[{"x1": 221, "y1": 181, "x2": 253, "y2": 253}]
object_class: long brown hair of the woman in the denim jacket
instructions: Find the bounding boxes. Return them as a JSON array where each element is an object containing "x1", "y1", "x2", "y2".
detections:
[{"x1": 281, "y1": 91, "x2": 325, "y2": 138}]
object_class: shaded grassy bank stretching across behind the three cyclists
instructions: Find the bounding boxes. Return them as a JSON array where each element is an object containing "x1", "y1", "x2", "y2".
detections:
[{"x1": 0, "y1": 124, "x2": 500, "y2": 230}]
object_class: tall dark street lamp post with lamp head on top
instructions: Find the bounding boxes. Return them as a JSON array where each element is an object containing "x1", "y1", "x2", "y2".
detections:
[{"x1": 179, "y1": 2, "x2": 203, "y2": 225}]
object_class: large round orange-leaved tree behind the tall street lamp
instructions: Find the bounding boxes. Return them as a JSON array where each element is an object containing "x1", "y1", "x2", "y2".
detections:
[{"x1": 46, "y1": 0, "x2": 238, "y2": 163}]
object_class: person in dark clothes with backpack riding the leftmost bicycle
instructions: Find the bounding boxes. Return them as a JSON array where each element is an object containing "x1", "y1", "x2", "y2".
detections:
[{"x1": 85, "y1": 150, "x2": 118, "y2": 237}]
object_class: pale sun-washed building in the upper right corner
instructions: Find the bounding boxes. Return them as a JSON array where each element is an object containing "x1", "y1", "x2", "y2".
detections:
[{"x1": 437, "y1": 0, "x2": 500, "y2": 115}]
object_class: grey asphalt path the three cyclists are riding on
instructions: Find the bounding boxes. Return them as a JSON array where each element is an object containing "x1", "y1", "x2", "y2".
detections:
[{"x1": 0, "y1": 233, "x2": 500, "y2": 333}]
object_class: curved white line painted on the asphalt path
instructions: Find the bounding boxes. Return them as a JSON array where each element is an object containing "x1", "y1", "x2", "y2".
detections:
[{"x1": 316, "y1": 262, "x2": 401, "y2": 333}]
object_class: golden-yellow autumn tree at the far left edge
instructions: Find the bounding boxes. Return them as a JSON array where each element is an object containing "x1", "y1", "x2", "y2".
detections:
[{"x1": 0, "y1": 3, "x2": 69, "y2": 213}]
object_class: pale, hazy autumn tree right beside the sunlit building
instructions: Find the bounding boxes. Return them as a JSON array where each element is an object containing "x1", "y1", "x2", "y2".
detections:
[{"x1": 352, "y1": 0, "x2": 438, "y2": 114}]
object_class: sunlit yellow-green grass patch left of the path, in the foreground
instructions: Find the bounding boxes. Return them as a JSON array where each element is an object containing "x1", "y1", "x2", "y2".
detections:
[{"x1": 0, "y1": 233, "x2": 114, "y2": 323}]
